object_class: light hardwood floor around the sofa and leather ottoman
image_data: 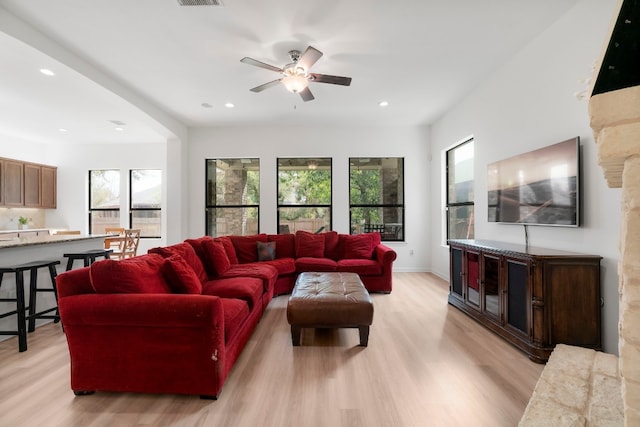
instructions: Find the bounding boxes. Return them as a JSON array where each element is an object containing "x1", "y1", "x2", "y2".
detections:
[{"x1": 0, "y1": 273, "x2": 543, "y2": 427}]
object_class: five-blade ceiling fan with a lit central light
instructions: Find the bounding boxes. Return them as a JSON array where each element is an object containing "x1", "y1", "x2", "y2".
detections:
[{"x1": 240, "y1": 46, "x2": 351, "y2": 102}]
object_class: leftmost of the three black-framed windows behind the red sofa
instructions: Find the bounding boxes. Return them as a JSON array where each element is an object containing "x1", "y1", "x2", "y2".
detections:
[{"x1": 205, "y1": 159, "x2": 260, "y2": 237}]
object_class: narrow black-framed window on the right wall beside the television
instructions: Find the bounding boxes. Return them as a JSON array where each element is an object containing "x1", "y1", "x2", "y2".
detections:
[{"x1": 446, "y1": 139, "x2": 474, "y2": 239}]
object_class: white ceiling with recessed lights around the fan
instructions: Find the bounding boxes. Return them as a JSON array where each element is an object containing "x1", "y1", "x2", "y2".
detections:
[{"x1": 0, "y1": 0, "x2": 579, "y2": 145}]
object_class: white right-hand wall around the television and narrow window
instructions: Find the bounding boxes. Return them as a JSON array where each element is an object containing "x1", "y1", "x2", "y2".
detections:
[{"x1": 430, "y1": 0, "x2": 620, "y2": 353}]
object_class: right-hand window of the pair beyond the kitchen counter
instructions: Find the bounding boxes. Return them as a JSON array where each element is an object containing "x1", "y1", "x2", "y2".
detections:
[{"x1": 129, "y1": 169, "x2": 162, "y2": 237}]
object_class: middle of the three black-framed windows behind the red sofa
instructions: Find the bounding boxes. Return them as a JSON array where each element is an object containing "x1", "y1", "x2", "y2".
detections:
[{"x1": 278, "y1": 158, "x2": 331, "y2": 234}]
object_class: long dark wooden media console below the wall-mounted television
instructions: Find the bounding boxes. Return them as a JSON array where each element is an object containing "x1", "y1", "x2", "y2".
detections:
[{"x1": 448, "y1": 240, "x2": 602, "y2": 363}]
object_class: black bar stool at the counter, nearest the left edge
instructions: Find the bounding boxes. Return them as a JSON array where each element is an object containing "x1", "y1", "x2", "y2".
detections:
[{"x1": 0, "y1": 260, "x2": 60, "y2": 352}]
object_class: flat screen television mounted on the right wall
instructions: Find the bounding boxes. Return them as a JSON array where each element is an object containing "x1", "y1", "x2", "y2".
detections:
[{"x1": 487, "y1": 137, "x2": 580, "y2": 227}]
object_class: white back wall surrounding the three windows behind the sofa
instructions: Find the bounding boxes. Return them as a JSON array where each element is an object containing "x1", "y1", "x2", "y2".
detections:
[{"x1": 189, "y1": 126, "x2": 431, "y2": 271}]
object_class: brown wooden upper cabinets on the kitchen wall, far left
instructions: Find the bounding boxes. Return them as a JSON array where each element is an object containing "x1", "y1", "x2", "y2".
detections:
[{"x1": 0, "y1": 159, "x2": 57, "y2": 208}]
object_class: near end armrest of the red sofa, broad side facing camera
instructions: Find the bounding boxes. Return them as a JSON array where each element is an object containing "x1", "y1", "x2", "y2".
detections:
[{"x1": 58, "y1": 294, "x2": 230, "y2": 396}]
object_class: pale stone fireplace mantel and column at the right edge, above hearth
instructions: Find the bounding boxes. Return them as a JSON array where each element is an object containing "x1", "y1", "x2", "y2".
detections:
[{"x1": 589, "y1": 81, "x2": 640, "y2": 426}]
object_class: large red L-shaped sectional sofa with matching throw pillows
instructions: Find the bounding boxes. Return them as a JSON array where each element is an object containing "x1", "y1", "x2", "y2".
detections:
[{"x1": 56, "y1": 232, "x2": 396, "y2": 398}]
